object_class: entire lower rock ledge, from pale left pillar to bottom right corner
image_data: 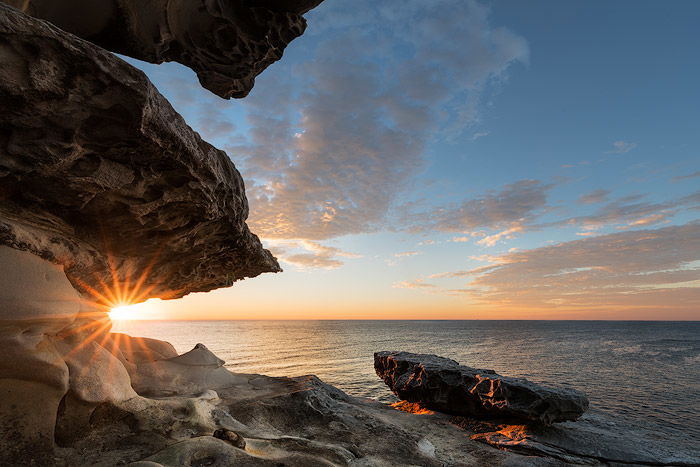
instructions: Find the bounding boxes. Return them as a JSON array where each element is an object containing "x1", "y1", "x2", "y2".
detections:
[{"x1": 0, "y1": 246, "x2": 700, "y2": 467}]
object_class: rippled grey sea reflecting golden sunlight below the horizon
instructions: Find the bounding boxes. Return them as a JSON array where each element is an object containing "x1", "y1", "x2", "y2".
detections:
[{"x1": 114, "y1": 321, "x2": 700, "y2": 446}]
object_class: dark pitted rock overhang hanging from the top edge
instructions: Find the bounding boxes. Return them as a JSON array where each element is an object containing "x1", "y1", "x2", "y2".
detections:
[{"x1": 3, "y1": 0, "x2": 322, "y2": 98}]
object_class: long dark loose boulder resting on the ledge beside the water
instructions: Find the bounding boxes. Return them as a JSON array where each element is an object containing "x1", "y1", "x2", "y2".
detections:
[{"x1": 374, "y1": 351, "x2": 588, "y2": 425}]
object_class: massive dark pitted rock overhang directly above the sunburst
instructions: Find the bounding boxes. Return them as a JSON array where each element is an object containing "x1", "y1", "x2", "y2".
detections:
[{"x1": 0, "y1": 2, "x2": 279, "y2": 301}]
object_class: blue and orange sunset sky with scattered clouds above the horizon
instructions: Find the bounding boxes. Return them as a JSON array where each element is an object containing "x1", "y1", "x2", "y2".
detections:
[{"x1": 113, "y1": 0, "x2": 700, "y2": 320}]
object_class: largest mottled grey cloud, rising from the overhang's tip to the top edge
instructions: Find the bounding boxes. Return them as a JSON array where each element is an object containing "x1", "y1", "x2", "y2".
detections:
[{"x1": 227, "y1": 0, "x2": 529, "y2": 240}]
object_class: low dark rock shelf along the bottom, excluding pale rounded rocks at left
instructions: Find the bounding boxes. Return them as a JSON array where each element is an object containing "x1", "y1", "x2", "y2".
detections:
[{"x1": 26, "y1": 338, "x2": 700, "y2": 467}]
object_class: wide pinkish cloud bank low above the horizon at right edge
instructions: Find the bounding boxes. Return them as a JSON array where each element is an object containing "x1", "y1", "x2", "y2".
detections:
[{"x1": 460, "y1": 223, "x2": 700, "y2": 309}]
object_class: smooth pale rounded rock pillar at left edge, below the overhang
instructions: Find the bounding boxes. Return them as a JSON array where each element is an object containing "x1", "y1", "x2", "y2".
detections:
[{"x1": 0, "y1": 246, "x2": 80, "y2": 460}]
